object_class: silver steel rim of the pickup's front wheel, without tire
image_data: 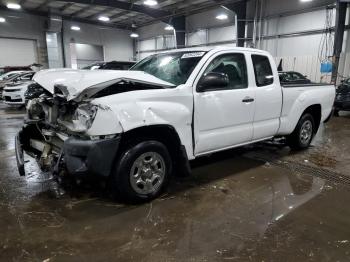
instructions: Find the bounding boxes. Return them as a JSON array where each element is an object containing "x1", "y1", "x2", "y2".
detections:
[{"x1": 130, "y1": 152, "x2": 166, "y2": 195}]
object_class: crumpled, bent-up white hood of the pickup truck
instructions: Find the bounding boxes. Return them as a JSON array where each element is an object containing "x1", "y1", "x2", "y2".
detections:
[{"x1": 33, "y1": 69, "x2": 174, "y2": 102}]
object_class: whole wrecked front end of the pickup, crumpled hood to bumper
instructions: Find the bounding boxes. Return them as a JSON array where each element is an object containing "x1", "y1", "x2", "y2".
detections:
[{"x1": 16, "y1": 69, "x2": 174, "y2": 180}]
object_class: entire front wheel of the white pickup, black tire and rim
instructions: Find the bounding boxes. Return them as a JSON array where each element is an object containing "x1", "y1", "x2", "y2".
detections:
[{"x1": 112, "y1": 141, "x2": 172, "y2": 202}]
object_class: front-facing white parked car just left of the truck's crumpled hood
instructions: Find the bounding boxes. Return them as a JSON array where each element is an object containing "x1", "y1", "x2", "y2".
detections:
[{"x1": 2, "y1": 81, "x2": 33, "y2": 106}]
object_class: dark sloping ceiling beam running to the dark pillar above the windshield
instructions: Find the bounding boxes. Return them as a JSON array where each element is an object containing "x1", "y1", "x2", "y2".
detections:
[{"x1": 53, "y1": 0, "x2": 171, "y2": 19}]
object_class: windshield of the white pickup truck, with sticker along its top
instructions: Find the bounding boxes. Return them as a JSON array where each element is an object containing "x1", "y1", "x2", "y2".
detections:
[{"x1": 130, "y1": 52, "x2": 205, "y2": 86}]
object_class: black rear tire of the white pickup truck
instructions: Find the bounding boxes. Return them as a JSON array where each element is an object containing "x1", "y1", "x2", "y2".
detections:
[{"x1": 287, "y1": 113, "x2": 316, "y2": 150}]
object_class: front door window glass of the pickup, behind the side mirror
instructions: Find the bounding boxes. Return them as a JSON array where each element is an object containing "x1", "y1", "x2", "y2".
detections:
[{"x1": 204, "y1": 54, "x2": 248, "y2": 89}]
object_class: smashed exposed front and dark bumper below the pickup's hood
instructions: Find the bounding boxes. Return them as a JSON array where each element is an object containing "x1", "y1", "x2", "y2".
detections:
[{"x1": 15, "y1": 87, "x2": 120, "y2": 177}]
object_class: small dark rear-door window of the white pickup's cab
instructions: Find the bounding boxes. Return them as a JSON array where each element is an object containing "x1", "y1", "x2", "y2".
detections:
[{"x1": 252, "y1": 55, "x2": 273, "y2": 86}]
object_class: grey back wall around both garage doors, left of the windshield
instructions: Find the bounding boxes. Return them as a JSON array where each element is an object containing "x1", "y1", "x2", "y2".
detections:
[{"x1": 0, "y1": 11, "x2": 134, "y2": 68}]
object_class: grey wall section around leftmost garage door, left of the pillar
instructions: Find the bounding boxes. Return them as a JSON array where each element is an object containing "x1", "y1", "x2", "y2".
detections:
[{"x1": 0, "y1": 11, "x2": 48, "y2": 67}]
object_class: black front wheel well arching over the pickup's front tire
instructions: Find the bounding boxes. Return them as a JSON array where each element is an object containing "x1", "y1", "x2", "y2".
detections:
[{"x1": 118, "y1": 125, "x2": 188, "y2": 173}]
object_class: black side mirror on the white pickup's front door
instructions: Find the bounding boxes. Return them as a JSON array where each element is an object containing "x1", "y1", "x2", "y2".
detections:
[{"x1": 197, "y1": 72, "x2": 230, "y2": 93}]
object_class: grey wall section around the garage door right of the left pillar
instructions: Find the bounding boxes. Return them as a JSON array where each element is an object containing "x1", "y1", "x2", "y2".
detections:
[{"x1": 63, "y1": 21, "x2": 134, "y2": 67}]
